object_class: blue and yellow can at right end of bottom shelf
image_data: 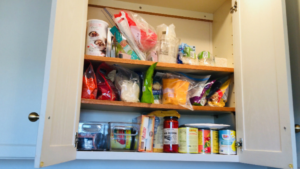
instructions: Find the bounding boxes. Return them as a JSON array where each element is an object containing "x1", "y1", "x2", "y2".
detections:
[{"x1": 219, "y1": 130, "x2": 236, "y2": 155}]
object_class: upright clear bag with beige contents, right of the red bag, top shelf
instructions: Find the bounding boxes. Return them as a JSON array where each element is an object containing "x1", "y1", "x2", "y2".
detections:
[{"x1": 157, "y1": 24, "x2": 180, "y2": 63}]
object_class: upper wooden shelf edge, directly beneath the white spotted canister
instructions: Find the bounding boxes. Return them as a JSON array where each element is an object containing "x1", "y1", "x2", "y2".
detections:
[{"x1": 84, "y1": 55, "x2": 234, "y2": 75}]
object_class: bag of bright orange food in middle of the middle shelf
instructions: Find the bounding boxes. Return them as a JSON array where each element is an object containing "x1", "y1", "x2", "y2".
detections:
[{"x1": 162, "y1": 79, "x2": 190, "y2": 105}]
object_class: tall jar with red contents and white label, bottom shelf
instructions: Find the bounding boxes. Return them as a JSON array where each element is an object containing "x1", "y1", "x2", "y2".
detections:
[{"x1": 164, "y1": 116, "x2": 178, "y2": 153}]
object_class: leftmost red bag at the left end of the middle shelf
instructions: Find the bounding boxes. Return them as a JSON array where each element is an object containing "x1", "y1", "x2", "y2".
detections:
[{"x1": 81, "y1": 60, "x2": 97, "y2": 99}]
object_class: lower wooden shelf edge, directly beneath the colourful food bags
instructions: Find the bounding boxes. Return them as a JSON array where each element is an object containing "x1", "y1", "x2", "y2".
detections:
[{"x1": 81, "y1": 99, "x2": 235, "y2": 114}]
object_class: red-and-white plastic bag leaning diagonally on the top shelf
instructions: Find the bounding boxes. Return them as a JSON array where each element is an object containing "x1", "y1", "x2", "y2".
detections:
[{"x1": 114, "y1": 11, "x2": 157, "y2": 60}]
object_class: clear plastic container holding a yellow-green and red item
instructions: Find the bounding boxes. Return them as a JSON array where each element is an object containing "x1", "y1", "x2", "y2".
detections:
[{"x1": 109, "y1": 122, "x2": 140, "y2": 151}]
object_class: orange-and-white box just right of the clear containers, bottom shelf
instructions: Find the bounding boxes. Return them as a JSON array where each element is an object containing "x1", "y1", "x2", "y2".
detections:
[{"x1": 133, "y1": 115, "x2": 155, "y2": 152}]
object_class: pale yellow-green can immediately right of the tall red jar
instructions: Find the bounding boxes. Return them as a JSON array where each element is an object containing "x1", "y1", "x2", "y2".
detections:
[{"x1": 178, "y1": 127, "x2": 198, "y2": 154}]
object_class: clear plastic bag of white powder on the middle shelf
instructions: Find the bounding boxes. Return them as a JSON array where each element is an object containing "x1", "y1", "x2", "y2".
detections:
[{"x1": 115, "y1": 65, "x2": 140, "y2": 102}]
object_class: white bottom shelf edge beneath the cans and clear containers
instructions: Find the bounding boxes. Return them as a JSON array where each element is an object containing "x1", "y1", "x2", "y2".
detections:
[{"x1": 76, "y1": 151, "x2": 239, "y2": 162}]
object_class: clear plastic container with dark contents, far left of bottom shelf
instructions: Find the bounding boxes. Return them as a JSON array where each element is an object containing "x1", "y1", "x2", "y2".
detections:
[{"x1": 77, "y1": 122, "x2": 110, "y2": 151}]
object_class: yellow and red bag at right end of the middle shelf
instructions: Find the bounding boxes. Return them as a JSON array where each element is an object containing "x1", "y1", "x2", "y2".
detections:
[{"x1": 208, "y1": 78, "x2": 232, "y2": 107}]
